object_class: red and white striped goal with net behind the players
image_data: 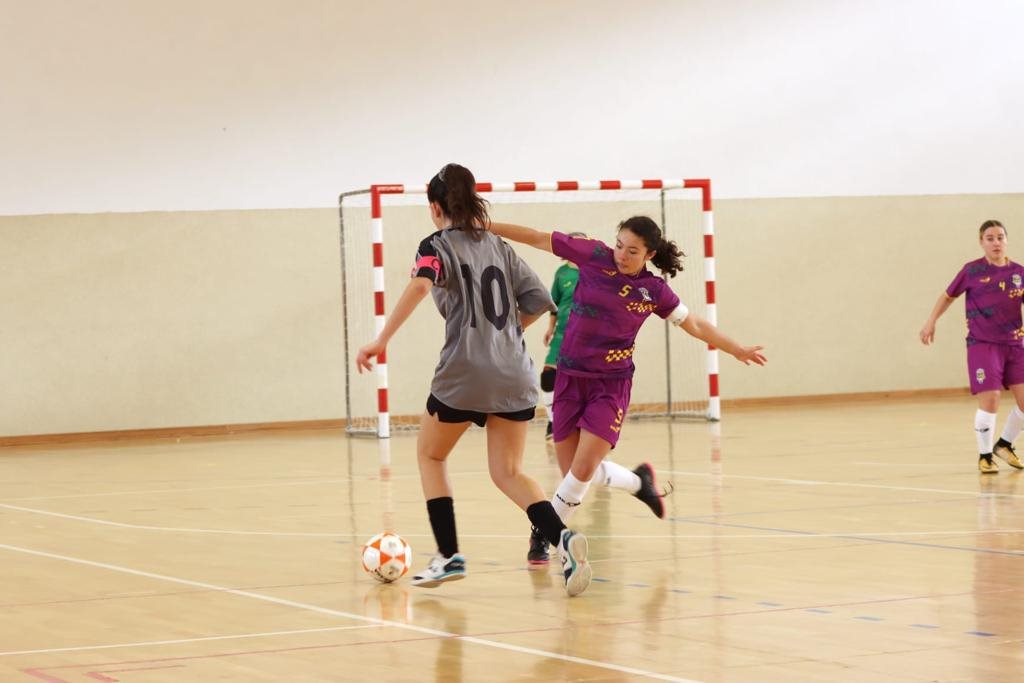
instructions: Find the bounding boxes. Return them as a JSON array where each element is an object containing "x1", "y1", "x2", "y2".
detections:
[{"x1": 338, "y1": 179, "x2": 721, "y2": 438}]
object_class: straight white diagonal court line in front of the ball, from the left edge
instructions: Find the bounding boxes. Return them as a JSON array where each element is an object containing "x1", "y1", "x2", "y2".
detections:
[{"x1": 0, "y1": 544, "x2": 698, "y2": 683}]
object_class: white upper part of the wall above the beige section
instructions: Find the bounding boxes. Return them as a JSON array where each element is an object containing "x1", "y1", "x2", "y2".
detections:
[{"x1": 0, "y1": 0, "x2": 1024, "y2": 215}]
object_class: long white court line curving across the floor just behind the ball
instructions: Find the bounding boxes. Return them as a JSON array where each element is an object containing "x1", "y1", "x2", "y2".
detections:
[{"x1": 0, "y1": 503, "x2": 1024, "y2": 541}]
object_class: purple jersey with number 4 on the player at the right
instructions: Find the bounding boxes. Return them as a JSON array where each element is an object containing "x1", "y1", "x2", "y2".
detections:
[{"x1": 946, "y1": 258, "x2": 1024, "y2": 346}]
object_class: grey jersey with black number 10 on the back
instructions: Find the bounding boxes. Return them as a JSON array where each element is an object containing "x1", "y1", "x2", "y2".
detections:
[{"x1": 414, "y1": 228, "x2": 555, "y2": 413}]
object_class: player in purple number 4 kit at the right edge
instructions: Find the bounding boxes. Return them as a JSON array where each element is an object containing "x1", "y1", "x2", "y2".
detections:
[{"x1": 921, "y1": 220, "x2": 1024, "y2": 474}]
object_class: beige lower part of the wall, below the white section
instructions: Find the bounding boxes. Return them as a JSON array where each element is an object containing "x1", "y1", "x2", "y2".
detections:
[{"x1": 0, "y1": 195, "x2": 1024, "y2": 436}]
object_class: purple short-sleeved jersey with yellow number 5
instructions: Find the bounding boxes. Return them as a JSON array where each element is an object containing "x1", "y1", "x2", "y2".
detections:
[{"x1": 551, "y1": 232, "x2": 679, "y2": 377}]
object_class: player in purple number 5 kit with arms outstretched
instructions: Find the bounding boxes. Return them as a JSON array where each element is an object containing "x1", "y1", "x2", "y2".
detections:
[{"x1": 490, "y1": 216, "x2": 766, "y2": 564}]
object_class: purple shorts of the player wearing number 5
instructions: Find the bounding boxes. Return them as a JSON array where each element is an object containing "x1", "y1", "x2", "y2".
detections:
[{"x1": 551, "y1": 370, "x2": 633, "y2": 447}]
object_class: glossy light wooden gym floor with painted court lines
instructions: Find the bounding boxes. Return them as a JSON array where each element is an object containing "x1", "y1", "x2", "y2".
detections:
[{"x1": 0, "y1": 396, "x2": 1024, "y2": 683}]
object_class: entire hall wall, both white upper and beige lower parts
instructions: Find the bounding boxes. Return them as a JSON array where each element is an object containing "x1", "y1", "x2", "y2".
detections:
[{"x1": 0, "y1": 0, "x2": 1024, "y2": 443}]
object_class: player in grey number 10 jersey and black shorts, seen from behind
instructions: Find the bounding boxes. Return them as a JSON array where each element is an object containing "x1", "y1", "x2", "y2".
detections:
[{"x1": 355, "y1": 164, "x2": 591, "y2": 595}]
